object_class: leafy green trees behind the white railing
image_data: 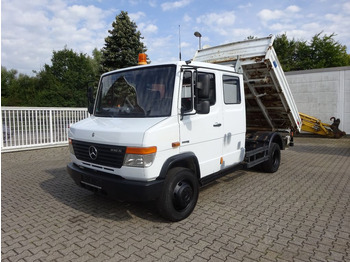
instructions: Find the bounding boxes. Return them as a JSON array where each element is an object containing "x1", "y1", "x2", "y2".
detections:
[{"x1": 1, "y1": 48, "x2": 101, "y2": 107}]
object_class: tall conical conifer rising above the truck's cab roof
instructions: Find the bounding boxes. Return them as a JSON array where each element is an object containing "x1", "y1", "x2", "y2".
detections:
[{"x1": 102, "y1": 11, "x2": 147, "y2": 72}]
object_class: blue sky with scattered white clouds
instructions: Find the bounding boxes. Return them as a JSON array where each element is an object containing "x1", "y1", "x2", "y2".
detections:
[{"x1": 1, "y1": 0, "x2": 350, "y2": 74}]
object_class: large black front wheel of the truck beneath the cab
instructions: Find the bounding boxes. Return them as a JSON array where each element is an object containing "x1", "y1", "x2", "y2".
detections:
[{"x1": 157, "y1": 167, "x2": 199, "y2": 222}]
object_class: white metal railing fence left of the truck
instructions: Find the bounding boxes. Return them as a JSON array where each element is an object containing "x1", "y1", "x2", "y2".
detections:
[{"x1": 1, "y1": 107, "x2": 89, "y2": 152}]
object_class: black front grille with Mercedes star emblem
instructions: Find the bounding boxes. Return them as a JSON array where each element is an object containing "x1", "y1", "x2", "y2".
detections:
[{"x1": 72, "y1": 140, "x2": 126, "y2": 168}]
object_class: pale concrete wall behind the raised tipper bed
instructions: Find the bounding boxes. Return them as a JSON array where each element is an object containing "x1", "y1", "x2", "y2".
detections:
[{"x1": 286, "y1": 66, "x2": 350, "y2": 134}]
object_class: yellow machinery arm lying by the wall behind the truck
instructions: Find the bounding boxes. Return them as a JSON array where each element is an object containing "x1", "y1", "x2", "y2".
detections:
[{"x1": 299, "y1": 113, "x2": 346, "y2": 138}]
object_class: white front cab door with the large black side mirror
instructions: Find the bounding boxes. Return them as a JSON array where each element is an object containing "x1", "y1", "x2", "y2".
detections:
[{"x1": 180, "y1": 70, "x2": 223, "y2": 177}]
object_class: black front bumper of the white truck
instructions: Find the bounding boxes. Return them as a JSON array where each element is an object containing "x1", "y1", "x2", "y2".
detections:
[{"x1": 67, "y1": 163, "x2": 164, "y2": 201}]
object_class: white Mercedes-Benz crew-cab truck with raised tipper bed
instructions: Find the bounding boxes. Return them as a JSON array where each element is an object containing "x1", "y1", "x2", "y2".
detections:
[{"x1": 67, "y1": 36, "x2": 301, "y2": 221}]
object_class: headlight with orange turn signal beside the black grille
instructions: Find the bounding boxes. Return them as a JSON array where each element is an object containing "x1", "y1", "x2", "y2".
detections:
[{"x1": 124, "y1": 146, "x2": 157, "y2": 167}]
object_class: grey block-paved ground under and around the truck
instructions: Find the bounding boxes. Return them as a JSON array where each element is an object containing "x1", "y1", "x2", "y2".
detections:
[{"x1": 1, "y1": 137, "x2": 350, "y2": 262}]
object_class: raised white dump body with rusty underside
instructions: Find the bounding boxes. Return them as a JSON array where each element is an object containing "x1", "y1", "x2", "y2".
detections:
[{"x1": 193, "y1": 36, "x2": 301, "y2": 131}]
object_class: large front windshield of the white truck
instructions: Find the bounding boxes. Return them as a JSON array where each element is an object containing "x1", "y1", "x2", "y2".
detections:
[{"x1": 95, "y1": 65, "x2": 176, "y2": 117}]
